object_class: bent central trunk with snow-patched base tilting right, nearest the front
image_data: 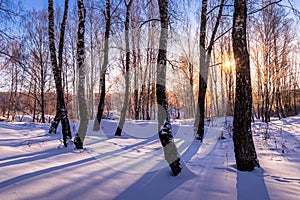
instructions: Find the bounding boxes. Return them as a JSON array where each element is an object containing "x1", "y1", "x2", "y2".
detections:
[{"x1": 156, "y1": 0, "x2": 181, "y2": 176}]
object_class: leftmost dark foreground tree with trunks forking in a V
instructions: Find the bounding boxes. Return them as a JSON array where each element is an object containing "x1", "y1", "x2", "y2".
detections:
[{"x1": 48, "y1": 0, "x2": 72, "y2": 146}]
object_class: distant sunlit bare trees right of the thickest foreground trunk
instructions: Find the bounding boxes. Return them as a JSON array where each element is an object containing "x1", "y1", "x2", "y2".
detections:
[{"x1": 250, "y1": 1, "x2": 294, "y2": 123}]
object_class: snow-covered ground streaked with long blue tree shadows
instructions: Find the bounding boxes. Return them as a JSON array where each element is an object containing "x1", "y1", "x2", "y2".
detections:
[{"x1": 0, "y1": 116, "x2": 300, "y2": 200}]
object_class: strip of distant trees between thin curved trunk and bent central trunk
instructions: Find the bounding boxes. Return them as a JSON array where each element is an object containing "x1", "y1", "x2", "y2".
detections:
[{"x1": 132, "y1": 0, "x2": 159, "y2": 120}]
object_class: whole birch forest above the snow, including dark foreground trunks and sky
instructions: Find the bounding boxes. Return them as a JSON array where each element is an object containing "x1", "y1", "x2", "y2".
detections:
[{"x1": 0, "y1": 0, "x2": 300, "y2": 175}]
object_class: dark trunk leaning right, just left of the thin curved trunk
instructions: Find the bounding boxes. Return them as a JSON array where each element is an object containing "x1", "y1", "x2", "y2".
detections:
[{"x1": 93, "y1": 0, "x2": 111, "y2": 131}]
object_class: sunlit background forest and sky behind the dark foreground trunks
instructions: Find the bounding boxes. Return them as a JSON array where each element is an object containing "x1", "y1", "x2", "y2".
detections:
[{"x1": 1, "y1": 0, "x2": 299, "y2": 122}]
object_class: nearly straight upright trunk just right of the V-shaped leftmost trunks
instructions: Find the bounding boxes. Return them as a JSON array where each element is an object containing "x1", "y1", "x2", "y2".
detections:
[{"x1": 74, "y1": 0, "x2": 88, "y2": 149}]
